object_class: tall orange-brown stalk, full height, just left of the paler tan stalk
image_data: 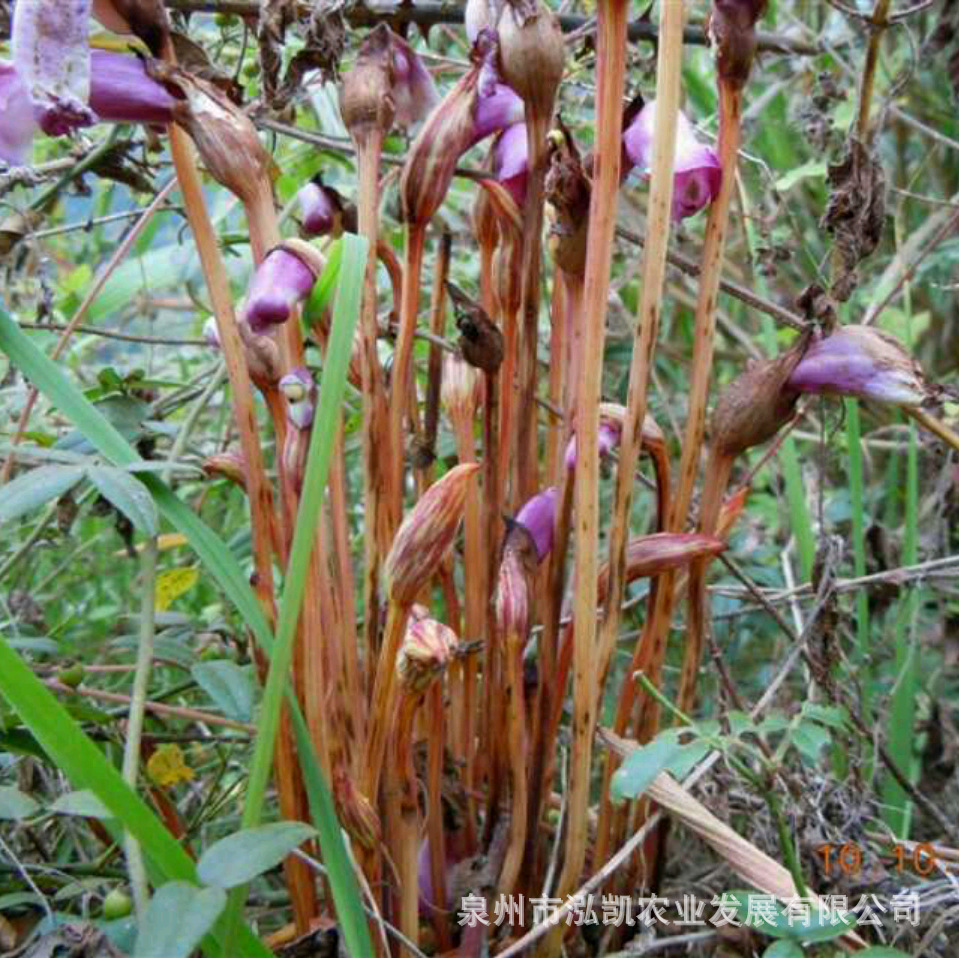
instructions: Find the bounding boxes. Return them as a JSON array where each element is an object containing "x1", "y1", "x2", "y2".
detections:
[{"x1": 546, "y1": 0, "x2": 632, "y2": 955}]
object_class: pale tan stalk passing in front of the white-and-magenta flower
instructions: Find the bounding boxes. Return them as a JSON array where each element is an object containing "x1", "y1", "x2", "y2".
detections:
[{"x1": 596, "y1": 0, "x2": 684, "y2": 884}]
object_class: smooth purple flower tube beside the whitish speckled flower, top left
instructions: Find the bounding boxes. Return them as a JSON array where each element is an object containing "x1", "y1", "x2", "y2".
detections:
[{"x1": 90, "y1": 50, "x2": 177, "y2": 124}]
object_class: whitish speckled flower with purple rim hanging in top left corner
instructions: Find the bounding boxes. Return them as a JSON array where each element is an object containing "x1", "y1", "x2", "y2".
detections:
[{"x1": 10, "y1": 0, "x2": 96, "y2": 136}]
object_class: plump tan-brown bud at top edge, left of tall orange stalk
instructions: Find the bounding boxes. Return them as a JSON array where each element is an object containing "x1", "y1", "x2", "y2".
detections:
[{"x1": 497, "y1": 0, "x2": 566, "y2": 122}]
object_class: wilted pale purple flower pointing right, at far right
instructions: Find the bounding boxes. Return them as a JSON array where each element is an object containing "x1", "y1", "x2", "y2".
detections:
[{"x1": 788, "y1": 326, "x2": 930, "y2": 406}]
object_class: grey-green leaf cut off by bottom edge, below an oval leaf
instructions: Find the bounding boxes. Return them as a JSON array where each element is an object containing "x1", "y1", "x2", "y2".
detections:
[{"x1": 133, "y1": 881, "x2": 226, "y2": 958}]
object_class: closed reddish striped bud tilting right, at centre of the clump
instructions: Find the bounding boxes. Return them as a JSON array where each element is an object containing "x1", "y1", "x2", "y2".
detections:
[{"x1": 384, "y1": 463, "x2": 479, "y2": 605}]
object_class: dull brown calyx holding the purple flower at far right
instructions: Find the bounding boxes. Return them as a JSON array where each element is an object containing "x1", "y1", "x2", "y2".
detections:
[{"x1": 709, "y1": 337, "x2": 806, "y2": 457}]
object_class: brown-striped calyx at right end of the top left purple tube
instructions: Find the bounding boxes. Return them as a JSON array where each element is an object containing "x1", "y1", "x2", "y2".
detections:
[{"x1": 147, "y1": 61, "x2": 272, "y2": 203}]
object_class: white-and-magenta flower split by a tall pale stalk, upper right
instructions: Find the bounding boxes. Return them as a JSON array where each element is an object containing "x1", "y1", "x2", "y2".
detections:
[{"x1": 623, "y1": 100, "x2": 723, "y2": 220}]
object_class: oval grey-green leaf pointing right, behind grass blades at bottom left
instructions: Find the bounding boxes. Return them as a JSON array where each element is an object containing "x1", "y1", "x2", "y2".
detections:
[{"x1": 196, "y1": 822, "x2": 316, "y2": 888}]
